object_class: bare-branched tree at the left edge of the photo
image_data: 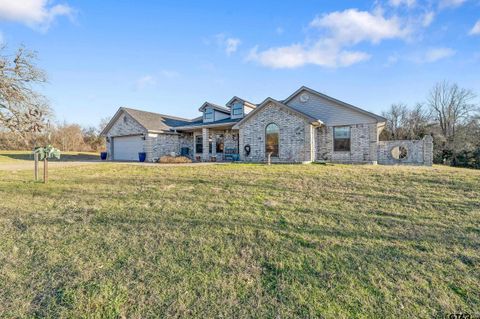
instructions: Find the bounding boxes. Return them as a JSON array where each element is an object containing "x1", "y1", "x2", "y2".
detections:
[{"x1": 0, "y1": 46, "x2": 50, "y2": 145}]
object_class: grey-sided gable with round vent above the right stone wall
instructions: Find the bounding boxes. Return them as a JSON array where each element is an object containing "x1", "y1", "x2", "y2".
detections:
[{"x1": 282, "y1": 86, "x2": 386, "y2": 124}]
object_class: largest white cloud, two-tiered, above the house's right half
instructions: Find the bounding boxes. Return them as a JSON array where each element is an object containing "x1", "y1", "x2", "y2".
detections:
[{"x1": 247, "y1": 9, "x2": 410, "y2": 68}]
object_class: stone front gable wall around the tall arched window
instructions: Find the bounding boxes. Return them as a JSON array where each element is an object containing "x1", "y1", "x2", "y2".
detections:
[{"x1": 239, "y1": 103, "x2": 315, "y2": 163}]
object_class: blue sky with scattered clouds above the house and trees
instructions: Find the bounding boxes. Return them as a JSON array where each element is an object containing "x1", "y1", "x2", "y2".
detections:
[{"x1": 0, "y1": 0, "x2": 480, "y2": 125}]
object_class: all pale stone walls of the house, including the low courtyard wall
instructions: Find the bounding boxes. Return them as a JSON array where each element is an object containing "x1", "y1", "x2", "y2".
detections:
[{"x1": 106, "y1": 108, "x2": 433, "y2": 166}]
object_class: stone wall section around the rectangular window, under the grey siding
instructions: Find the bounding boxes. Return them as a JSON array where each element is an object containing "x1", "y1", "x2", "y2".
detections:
[{"x1": 316, "y1": 123, "x2": 379, "y2": 164}]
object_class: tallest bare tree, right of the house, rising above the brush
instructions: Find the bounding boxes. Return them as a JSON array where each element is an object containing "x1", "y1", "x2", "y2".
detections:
[{"x1": 427, "y1": 81, "x2": 477, "y2": 149}]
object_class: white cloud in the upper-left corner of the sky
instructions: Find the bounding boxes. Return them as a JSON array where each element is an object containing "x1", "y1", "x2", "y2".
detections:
[{"x1": 0, "y1": 0, "x2": 74, "y2": 31}]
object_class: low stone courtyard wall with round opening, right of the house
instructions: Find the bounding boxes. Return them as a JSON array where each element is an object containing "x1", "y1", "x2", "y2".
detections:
[{"x1": 378, "y1": 135, "x2": 433, "y2": 166}]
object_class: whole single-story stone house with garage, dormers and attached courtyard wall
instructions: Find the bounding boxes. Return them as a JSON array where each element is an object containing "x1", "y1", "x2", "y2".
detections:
[{"x1": 102, "y1": 87, "x2": 433, "y2": 165}]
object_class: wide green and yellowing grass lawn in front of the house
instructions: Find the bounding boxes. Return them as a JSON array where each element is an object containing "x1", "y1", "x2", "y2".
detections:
[{"x1": 0, "y1": 164, "x2": 480, "y2": 318}]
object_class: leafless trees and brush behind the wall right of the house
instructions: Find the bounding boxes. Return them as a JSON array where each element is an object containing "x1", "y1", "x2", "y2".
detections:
[{"x1": 380, "y1": 81, "x2": 480, "y2": 168}]
